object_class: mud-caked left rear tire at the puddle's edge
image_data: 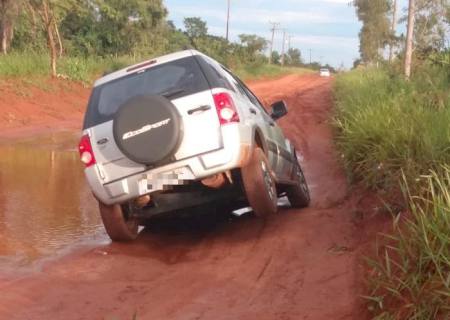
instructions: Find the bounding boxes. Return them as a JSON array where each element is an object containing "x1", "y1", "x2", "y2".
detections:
[{"x1": 99, "y1": 202, "x2": 139, "y2": 242}]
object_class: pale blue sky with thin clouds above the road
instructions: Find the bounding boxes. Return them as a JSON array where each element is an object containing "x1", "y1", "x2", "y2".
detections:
[{"x1": 165, "y1": 0, "x2": 412, "y2": 68}]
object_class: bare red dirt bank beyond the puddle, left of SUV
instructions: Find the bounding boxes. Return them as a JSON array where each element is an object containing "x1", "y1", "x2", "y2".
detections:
[{"x1": 0, "y1": 79, "x2": 90, "y2": 138}]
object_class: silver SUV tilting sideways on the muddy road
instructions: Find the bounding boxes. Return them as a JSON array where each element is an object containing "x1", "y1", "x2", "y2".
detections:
[{"x1": 79, "y1": 50, "x2": 310, "y2": 241}]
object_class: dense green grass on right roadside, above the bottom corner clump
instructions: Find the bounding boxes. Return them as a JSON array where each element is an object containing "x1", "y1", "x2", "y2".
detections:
[{"x1": 335, "y1": 68, "x2": 450, "y2": 190}]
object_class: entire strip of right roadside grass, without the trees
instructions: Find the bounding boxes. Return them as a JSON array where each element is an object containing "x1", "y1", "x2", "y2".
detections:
[{"x1": 334, "y1": 65, "x2": 450, "y2": 320}]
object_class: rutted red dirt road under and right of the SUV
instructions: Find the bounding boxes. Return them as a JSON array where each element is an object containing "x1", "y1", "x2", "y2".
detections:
[{"x1": 0, "y1": 75, "x2": 370, "y2": 320}]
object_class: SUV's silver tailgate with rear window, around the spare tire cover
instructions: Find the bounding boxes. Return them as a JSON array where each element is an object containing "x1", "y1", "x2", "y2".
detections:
[{"x1": 84, "y1": 56, "x2": 222, "y2": 183}]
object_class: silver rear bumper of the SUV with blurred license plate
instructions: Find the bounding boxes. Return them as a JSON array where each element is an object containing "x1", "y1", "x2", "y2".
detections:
[{"x1": 85, "y1": 124, "x2": 252, "y2": 204}]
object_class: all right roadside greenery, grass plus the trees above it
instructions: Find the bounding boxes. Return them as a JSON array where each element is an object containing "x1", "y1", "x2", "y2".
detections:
[{"x1": 342, "y1": 0, "x2": 450, "y2": 320}]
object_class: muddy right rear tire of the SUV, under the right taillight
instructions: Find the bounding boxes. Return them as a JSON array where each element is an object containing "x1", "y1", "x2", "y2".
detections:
[{"x1": 241, "y1": 148, "x2": 278, "y2": 217}]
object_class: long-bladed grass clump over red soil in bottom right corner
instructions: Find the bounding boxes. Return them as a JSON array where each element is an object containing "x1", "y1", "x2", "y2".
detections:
[{"x1": 367, "y1": 166, "x2": 450, "y2": 320}]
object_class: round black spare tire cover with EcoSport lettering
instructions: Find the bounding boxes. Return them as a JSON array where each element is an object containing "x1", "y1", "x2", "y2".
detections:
[{"x1": 113, "y1": 96, "x2": 183, "y2": 165}]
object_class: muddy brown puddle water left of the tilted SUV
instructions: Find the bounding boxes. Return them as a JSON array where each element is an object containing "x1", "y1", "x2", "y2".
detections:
[{"x1": 0, "y1": 135, "x2": 105, "y2": 269}]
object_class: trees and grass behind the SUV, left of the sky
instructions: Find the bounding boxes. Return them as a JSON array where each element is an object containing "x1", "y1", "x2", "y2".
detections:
[{"x1": 0, "y1": 0, "x2": 312, "y2": 82}]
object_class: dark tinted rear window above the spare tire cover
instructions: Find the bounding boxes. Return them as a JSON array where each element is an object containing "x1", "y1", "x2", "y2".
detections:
[{"x1": 83, "y1": 57, "x2": 209, "y2": 129}]
